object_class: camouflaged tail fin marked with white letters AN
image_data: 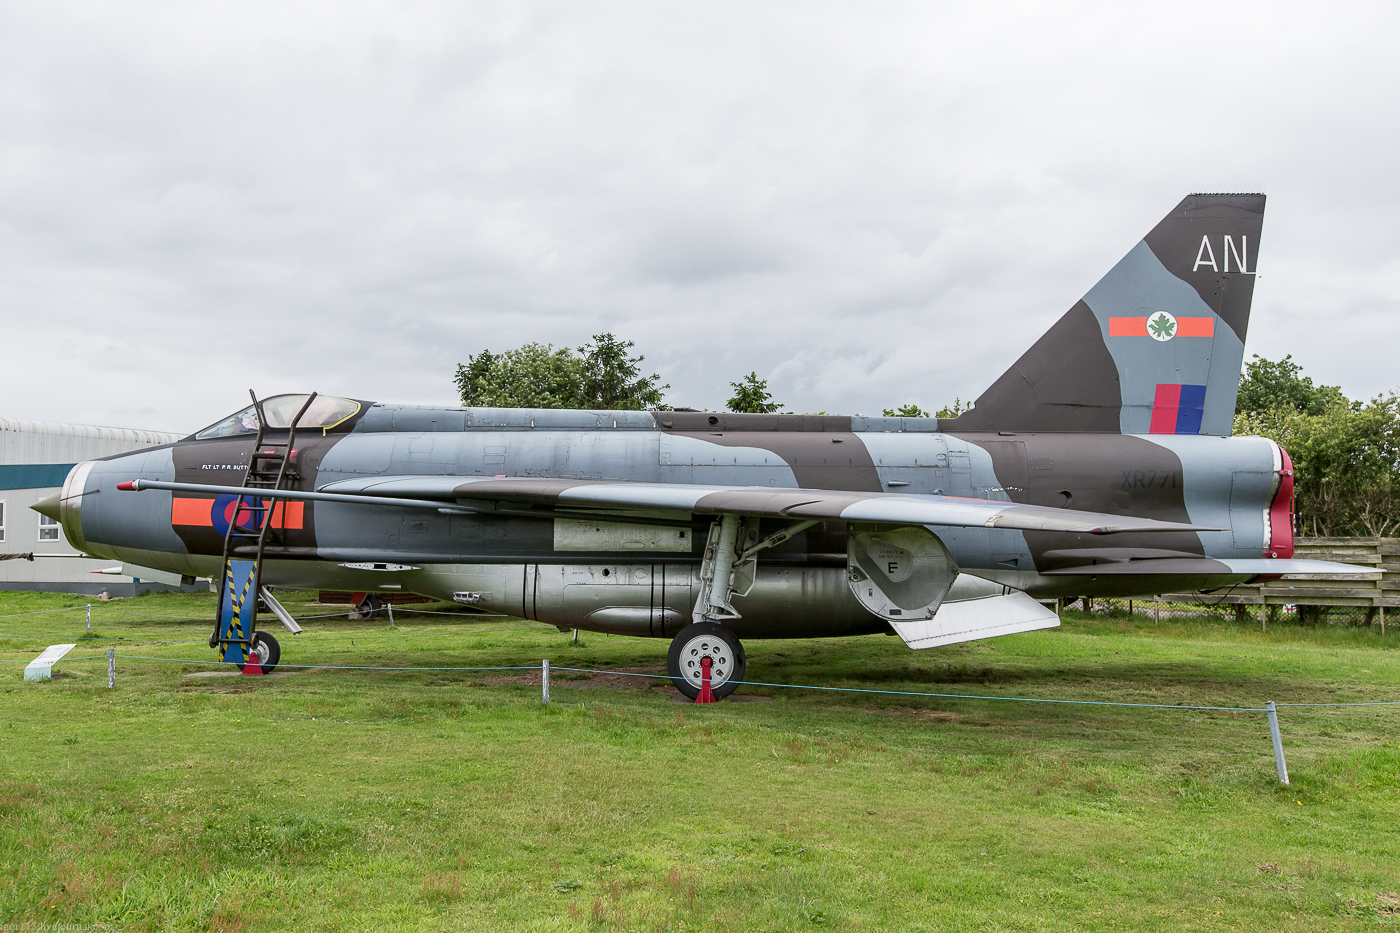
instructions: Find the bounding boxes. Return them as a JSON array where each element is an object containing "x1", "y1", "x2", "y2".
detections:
[{"x1": 938, "y1": 195, "x2": 1264, "y2": 437}]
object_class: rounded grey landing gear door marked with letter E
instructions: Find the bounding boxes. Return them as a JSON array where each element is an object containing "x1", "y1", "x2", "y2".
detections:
[{"x1": 846, "y1": 524, "x2": 958, "y2": 622}]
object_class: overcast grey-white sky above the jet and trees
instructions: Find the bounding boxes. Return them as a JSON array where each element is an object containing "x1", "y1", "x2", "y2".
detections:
[{"x1": 0, "y1": 0, "x2": 1400, "y2": 431}]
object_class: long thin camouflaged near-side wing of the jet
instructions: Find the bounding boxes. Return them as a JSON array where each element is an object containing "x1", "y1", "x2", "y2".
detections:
[{"x1": 318, "y1": 476, "x2": 1218, "y2": 535}]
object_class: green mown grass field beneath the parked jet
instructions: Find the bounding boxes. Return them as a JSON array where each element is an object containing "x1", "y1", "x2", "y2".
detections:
[{"x1": 0, "y1": 593, "x2": 1400, "y2": 933}]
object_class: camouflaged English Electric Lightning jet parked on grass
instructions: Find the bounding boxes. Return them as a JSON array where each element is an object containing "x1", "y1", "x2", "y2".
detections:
[{"x1": 38, "y1": 195, "x2": 1366, "y2": 698}]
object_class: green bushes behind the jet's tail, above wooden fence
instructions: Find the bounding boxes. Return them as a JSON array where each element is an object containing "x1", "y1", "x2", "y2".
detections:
[{"x1": 1235, "y1": 392, "x2": 1400, "y2": 537}]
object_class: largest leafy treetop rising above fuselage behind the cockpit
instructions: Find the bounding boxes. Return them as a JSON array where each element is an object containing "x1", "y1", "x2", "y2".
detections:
[{"x1": 454, "y1": 333, "x2": 671, "y2": 409}]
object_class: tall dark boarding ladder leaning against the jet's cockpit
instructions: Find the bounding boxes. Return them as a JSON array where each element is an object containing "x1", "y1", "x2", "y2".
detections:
[{"x1": 209, "y1": 389, "x2": 316, "y2": 661}]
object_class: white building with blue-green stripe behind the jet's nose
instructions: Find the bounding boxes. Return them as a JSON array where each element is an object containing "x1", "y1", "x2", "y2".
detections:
[{"x1": 0, "y1": 417, "x2": 193, "y2": 597}]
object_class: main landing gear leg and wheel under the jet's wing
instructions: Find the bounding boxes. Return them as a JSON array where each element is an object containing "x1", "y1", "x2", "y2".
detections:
[{"x1": 666, "y1": 514, "x2": 816, "y2": 702}]
